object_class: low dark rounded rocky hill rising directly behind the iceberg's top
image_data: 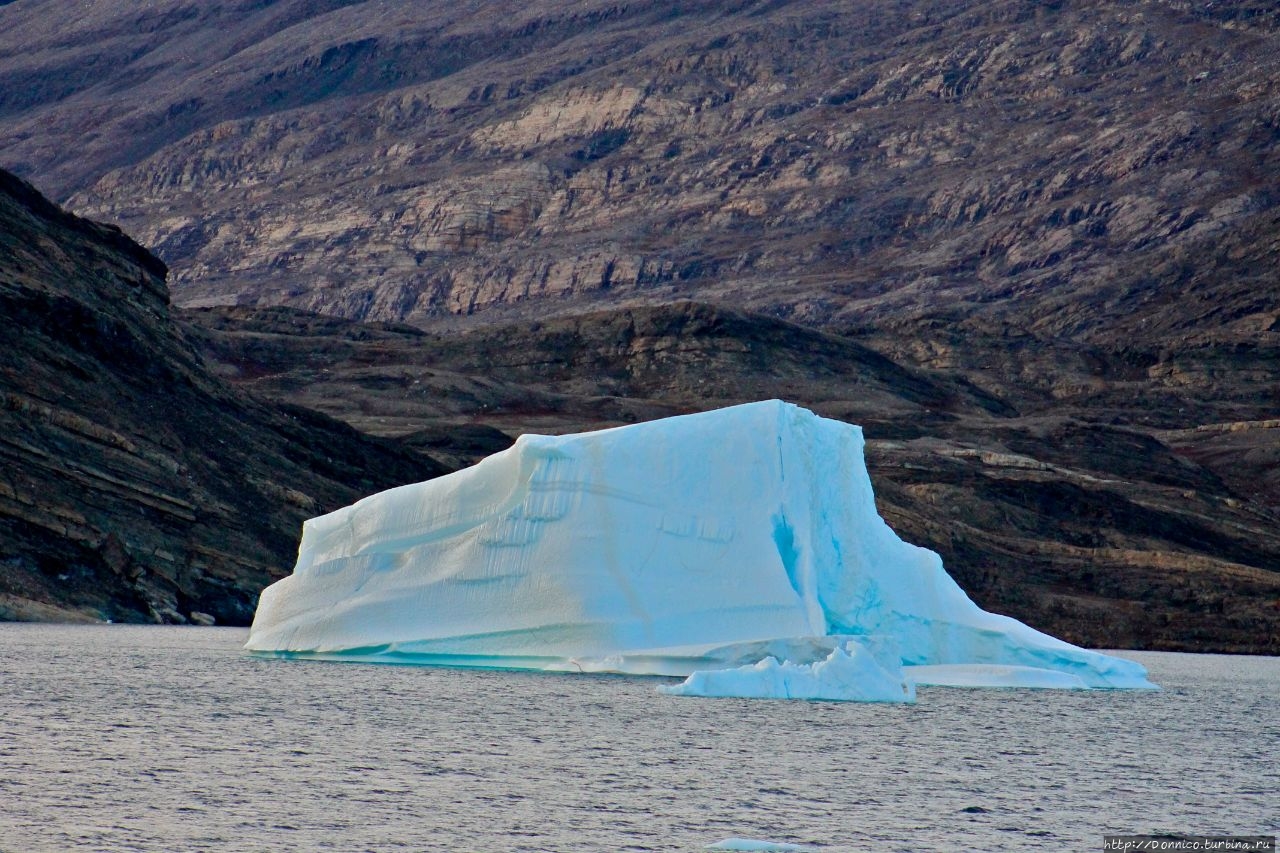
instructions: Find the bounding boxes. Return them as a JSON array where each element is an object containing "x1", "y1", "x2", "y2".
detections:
[{"x1": 183, "y1": 302, "x2": 1004, "y2": 435}]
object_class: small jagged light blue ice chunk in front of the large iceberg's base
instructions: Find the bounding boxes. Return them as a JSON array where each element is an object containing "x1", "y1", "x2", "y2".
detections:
[{"x1": 658, "y1": 642, "x2": 915, "y2": 702}]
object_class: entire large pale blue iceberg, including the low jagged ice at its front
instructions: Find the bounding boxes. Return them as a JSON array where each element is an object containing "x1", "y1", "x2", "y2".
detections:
[{"x1": 247, "y1": 401, "x2": 1153, "y2": 702}]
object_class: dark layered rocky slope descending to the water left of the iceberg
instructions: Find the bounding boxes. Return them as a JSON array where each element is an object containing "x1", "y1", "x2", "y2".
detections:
[{"x1": 0, "y1": 172, "x2": 440, "y2": 624}]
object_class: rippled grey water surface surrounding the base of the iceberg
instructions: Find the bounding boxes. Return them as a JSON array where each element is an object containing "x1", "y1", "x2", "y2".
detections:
[{"x1": 0, "y1": 624, "x2": 1280, "y2": 853}]
